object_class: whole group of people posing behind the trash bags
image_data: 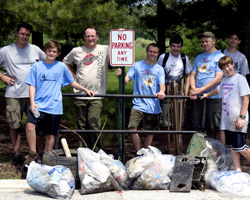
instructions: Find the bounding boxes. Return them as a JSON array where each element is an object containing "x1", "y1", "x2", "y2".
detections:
[{"x1": 0, "y1": 22, "x2": 250, "y2": 170}]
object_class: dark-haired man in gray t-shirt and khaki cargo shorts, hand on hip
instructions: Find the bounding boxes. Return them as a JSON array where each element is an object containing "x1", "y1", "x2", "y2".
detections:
[{"x1": 0, "y1": 22, "x2": 46, "y2": 165}]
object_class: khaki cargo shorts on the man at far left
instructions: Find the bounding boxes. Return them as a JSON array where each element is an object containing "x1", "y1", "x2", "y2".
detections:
[{"x1": 6, "y1": 98, "x2": 30, "y2": 129}]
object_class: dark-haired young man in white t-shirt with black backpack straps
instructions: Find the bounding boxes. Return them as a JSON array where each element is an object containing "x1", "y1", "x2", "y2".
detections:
[{"x1": 157, "y1": 35, "x2": 192, "y2": 154}]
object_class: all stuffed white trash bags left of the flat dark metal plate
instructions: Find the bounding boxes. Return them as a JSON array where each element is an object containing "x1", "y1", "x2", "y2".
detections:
[{"x1": 26, "y1": 146, "x2": 175, "y2": 199}]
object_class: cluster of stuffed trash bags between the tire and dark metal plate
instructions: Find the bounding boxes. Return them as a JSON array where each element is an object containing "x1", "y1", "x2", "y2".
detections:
[{"x1": 77, "y1": 146, "x2": 175, "y2": 194}]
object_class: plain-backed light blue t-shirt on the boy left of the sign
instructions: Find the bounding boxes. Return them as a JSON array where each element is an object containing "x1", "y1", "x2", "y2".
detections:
[{"x1": 25, "y1": 61, "x2": 74, "y2": 115}]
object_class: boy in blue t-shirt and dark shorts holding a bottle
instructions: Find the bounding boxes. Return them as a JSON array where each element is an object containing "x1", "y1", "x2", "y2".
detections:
[{"x1": 24, "y1": 41, "x2": 95, "y2": 164}]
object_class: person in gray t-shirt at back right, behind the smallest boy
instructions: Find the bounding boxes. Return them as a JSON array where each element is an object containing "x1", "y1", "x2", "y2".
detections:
[{"x1": 222, "y1": 32, "x2": 249, "y2": 77}]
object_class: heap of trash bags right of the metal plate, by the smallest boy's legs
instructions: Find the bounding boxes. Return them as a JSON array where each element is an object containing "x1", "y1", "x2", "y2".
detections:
[{"x1": 188, "y1": 133, "x2": 250, "y2": 196}]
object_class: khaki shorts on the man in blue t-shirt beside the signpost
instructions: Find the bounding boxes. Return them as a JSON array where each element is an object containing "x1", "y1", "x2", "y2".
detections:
[{"x1": 128, "y1": 109, "x2": 160, "y2": 130}]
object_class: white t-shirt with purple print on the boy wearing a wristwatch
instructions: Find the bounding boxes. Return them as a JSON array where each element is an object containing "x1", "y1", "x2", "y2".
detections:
[{"x1": 218, "y1": 74, "x2": 250, "y2": 133}]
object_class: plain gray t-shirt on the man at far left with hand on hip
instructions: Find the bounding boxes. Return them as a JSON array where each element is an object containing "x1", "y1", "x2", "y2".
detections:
[{"x1": 0, "y1": 43, "x2": 46, "y2": 98}]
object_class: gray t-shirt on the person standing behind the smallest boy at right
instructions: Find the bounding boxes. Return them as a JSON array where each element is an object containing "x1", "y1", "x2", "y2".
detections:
[{"x1": 223, "y1": 49, "x2": 249, "y2": 75}]
